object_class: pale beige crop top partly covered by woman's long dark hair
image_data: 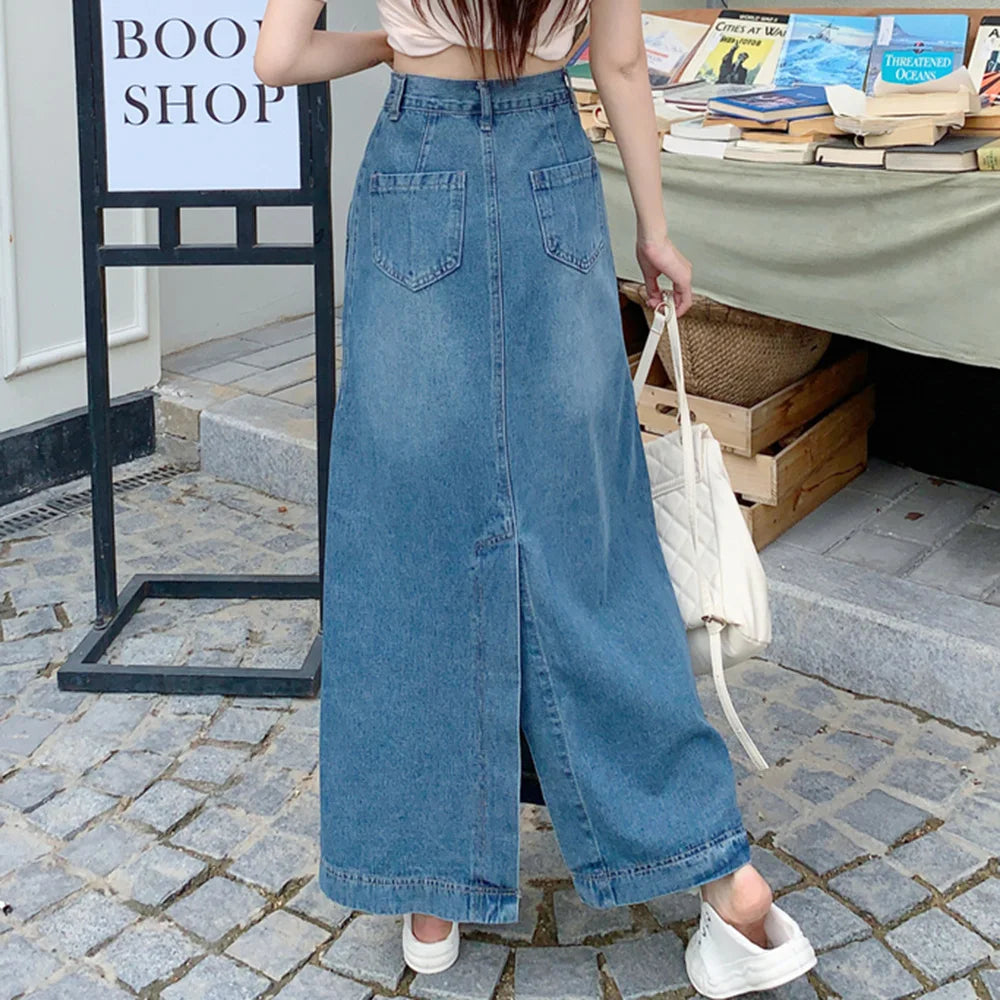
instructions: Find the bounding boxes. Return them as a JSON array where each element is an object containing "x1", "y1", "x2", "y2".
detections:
[{"x1": 376, "y1": 0, "x2": 589, "y2": 59}]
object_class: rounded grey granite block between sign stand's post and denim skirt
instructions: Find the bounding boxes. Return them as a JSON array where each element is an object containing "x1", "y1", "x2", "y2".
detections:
[{"x1": 201, "y1": 395, "x2": 317, "y2": 506}]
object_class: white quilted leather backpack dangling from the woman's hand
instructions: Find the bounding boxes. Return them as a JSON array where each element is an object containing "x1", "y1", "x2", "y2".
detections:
[{"x1": 633, "y1": 291, "x2": 771, "y2": 770}]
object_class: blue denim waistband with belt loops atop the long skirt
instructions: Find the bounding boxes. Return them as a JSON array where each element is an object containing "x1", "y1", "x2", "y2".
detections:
[{"x1": 382, "y1": 67, "x2": 575, "y2": 115}]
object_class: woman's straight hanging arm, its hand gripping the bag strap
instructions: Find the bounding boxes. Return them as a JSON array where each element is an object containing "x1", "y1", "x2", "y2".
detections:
[{"x1": 590, "y1": 0, "x2": 691, "y2": 315}]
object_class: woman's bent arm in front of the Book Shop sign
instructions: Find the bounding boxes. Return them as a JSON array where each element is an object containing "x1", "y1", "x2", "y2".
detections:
[{"x1": 253, "y1": 0, "x2": 392, "y2": 87}]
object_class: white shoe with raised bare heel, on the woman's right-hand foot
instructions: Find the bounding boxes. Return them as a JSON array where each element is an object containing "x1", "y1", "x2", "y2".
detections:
[{"x1": 684, "y1": 900, "x2": 816, "y2": 1000}]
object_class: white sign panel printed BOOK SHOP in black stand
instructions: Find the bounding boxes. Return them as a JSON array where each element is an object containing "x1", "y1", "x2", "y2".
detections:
[{"x1": 101, "y1": 0, "x2": 302, "y2": 191}]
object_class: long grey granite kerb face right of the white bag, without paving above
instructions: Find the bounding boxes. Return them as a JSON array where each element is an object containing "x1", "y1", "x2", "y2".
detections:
[{"x1": 761, "y1": 539, "x2": 1000, "y2": 736}]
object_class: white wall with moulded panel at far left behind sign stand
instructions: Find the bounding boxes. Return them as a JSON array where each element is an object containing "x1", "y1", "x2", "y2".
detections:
[{"x1": 0, "y1": 0, "x2": 159, "y2": 431}]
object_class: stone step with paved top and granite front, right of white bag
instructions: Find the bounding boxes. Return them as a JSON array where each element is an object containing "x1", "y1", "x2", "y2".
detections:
[{"x1": 761, "y1": 457, "x2": 1000, "y2": 735}]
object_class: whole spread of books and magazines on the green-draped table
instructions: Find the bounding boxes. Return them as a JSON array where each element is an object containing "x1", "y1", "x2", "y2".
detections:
[{"x1": 567, "y1": 9, "x2": 1000, "y2": 171}]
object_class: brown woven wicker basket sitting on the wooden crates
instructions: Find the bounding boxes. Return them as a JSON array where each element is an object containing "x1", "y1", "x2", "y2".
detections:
[{"x1": 641, "y1": 295, "x2": 833, "y2": 406}]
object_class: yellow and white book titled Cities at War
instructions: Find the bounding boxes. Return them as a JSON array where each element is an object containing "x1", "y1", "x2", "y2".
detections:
[{"x1": 680, "y1": 10, "x2": 788, "y2": 87}]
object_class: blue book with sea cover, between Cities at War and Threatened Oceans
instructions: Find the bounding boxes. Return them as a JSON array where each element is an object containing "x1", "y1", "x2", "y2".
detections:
[{"x1": 774, "y1": 14, "x2": 878, "y2": 90}]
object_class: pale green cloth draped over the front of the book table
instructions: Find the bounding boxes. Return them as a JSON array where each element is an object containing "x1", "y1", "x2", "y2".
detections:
[{"x1": 594, "y1": 142, "x2": 1000, "y2": 368}]
